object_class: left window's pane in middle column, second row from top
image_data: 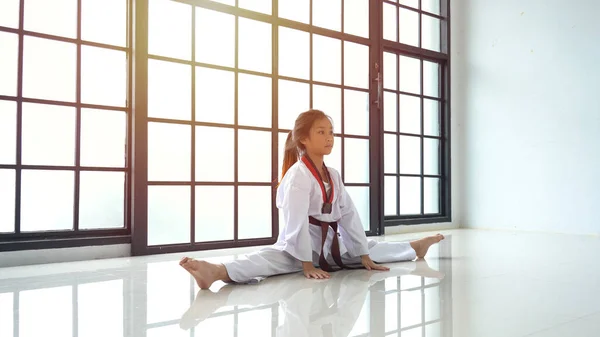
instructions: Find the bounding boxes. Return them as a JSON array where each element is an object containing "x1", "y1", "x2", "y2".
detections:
[{"x1": 23, "y1": 36, "x2": 77, "y2": 102}]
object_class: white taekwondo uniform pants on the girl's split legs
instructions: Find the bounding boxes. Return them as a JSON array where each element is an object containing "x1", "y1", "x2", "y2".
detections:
[{"x1": 224, "y1": 240, "x2": 417, "y2": 283}]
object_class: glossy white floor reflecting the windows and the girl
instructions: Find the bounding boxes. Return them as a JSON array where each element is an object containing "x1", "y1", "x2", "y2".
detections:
[{"x1": 0, "y1": 230, "x2": 600, "y2": 337}]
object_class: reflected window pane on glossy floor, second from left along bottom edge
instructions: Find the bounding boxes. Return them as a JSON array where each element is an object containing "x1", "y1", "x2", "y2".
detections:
[{"x1": 18, "y1": 286, "x2": 74, "y2": 337}]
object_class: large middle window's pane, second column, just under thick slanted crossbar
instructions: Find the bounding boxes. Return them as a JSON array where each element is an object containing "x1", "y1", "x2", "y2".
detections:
[{"x1": 196, "y1": 7, "x2": 235, "y2": 68}]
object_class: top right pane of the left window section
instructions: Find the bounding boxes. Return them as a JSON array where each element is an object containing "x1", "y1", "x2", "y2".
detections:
[{"x1": 81, "y1": 0, "x2": 128, "y2": 47}]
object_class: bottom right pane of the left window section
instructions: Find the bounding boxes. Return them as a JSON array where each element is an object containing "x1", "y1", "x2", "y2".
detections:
[{"x1": 79, "y1": 171, "x2": 125, "y2": 229}]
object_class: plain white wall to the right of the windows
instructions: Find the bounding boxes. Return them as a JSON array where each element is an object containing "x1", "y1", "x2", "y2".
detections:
[{"x1": 452, "y1": 0, "x2": 600, "y2": 234}]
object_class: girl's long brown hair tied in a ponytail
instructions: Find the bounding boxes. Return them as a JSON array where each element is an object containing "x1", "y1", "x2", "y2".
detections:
[{"x1": 281, "y1": 110, "x2": 333, "y2": 184}]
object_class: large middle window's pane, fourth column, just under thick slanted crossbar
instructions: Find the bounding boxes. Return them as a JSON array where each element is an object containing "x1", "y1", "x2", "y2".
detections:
[{"x1": 279, "y1": 27, "x2": 310, "y2": 80}]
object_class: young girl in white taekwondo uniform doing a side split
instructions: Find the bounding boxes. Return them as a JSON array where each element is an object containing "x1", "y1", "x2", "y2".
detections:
[{"x1": 179, "y1": 110, "x2": 444, "y2": 289}]
